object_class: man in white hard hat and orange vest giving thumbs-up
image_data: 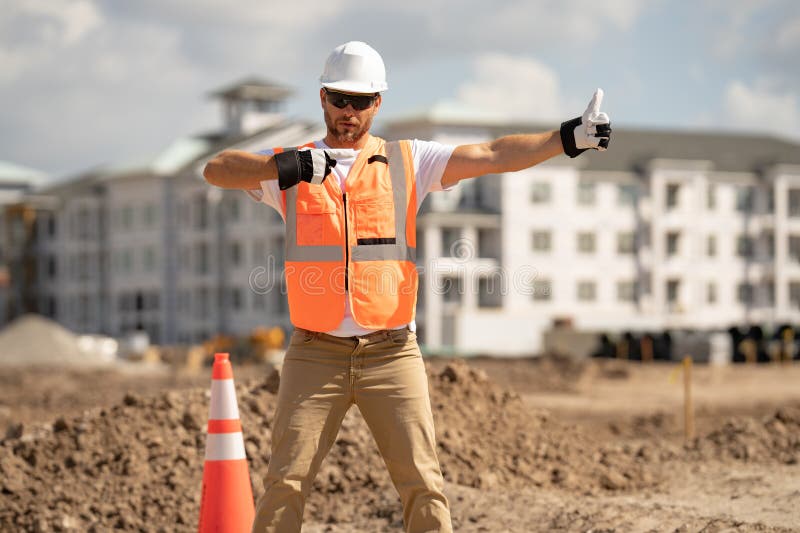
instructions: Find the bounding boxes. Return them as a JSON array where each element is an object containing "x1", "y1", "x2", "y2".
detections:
[{"x1": 204, "y1": 42, "x2": 611, "y2": 532}]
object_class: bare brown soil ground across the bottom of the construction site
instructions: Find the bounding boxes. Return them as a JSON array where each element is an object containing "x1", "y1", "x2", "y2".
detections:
[{"x1": 0, "y1": 357, "x2": 800, "y2": 533}]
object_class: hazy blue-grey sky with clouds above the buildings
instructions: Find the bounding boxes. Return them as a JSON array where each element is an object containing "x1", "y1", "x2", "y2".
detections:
[{"x1": 0, "y1": 0, "x2": 800, "y2": 177}]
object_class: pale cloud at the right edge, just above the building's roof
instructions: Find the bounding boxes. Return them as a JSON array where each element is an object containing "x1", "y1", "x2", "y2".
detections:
[{"x1": 722, "y1": 80, "x2": 800, "y2": 138}]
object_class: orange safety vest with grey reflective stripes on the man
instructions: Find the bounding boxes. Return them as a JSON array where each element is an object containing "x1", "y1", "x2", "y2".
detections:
[{"x1": 275, "y1": 136, "x2": 419, "y2": 331}]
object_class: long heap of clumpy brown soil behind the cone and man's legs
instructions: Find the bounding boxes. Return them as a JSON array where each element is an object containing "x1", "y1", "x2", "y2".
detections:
[{"x1": 0, "y1": 362, "x2": 800, "y2": 532}]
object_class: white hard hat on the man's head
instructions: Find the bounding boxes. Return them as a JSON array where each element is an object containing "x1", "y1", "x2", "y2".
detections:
[{"x1": 319, "y1": 41, "x2": 389, "y2": 94}]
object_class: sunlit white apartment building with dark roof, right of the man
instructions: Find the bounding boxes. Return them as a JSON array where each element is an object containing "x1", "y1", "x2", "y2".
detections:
[{"x1": 386, "y1": 108, "x2": 800, "y2": 355}]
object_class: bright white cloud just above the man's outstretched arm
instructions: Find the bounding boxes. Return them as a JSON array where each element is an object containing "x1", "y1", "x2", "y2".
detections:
[{"x1": 450, "y1": 53, "x2": 563, "y2": 121}]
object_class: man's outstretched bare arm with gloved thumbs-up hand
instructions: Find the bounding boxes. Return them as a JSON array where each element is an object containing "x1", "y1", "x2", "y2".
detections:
[{"x1": 442, "y1": 89, "x2": 611, "y2": 188}]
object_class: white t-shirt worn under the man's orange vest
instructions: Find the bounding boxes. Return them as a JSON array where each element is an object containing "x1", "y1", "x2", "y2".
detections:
[{"x1": 246, "y1": 139, "x2": 455, "y2": 337}]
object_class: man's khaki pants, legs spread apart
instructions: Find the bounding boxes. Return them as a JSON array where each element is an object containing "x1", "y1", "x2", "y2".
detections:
[{"x1": 253, "y1": 329, "x2": 452, "y2": 533}]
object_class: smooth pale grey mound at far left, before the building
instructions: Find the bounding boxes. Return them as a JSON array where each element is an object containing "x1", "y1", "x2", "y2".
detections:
[{"x1": 0, "y1": 314, "x2": 110, "y2": 367}]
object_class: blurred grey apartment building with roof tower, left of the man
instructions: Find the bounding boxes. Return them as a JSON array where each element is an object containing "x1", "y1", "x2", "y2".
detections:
[{"x1": 3, "y1": 79, "x2": 324, "y2": 343}]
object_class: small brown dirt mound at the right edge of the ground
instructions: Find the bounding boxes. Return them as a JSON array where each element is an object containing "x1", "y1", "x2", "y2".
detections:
[{"x1": 693, "y1": 406, "x2": 800, "y2": 465}]
